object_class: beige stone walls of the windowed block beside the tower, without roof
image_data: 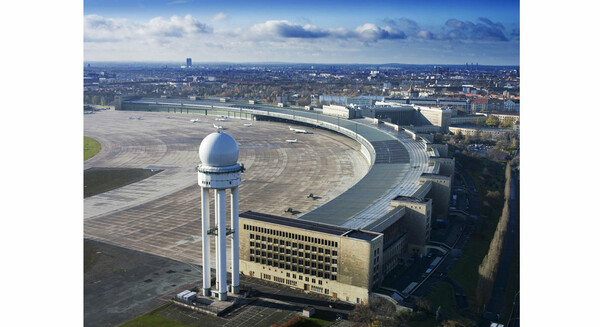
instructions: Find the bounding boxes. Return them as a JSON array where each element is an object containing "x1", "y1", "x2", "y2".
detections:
[{"x1": 240, "y1": 217, "x2": 376, "y2": 303}]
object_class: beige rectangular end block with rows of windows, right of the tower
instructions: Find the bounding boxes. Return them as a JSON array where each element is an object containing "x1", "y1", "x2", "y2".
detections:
[{"x1": 240, "y1": 211, "x2": 383, "y2": 303}]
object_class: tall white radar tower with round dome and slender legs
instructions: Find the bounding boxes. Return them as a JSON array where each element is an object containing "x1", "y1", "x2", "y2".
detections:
[{"x1": 196, "y1": 131, "x2": 243, "y2": 301}]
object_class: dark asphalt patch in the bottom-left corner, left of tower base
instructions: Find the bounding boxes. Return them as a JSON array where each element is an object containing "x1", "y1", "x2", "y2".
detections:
[{"x1": 83, "y1": 241, "x2": 202, "y2": 327}]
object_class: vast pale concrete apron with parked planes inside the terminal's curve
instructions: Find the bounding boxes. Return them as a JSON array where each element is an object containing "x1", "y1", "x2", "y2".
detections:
[{"x1": 84, "y1": 111, "x2": 369, "y2": 264}]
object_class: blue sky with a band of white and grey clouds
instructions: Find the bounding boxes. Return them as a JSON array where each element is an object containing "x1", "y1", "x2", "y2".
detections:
[{"x1": 83, "y1": 0, "x2": 520, "y2": 65}]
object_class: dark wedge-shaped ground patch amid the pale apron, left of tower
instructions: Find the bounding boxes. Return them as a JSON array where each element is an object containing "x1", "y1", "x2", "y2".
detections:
[{"x1": 83, "y1": 168, "x2": 162, "y2": 198}]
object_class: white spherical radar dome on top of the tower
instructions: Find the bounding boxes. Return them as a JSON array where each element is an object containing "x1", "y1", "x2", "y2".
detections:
[{"x1": 198, "y1": 131, "x2": 240, "y2": 167}]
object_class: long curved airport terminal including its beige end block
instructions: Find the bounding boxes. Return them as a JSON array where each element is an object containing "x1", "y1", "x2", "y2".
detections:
[{"x1": 116, "y1": 97, "x2": 454, "y2": 303}]
